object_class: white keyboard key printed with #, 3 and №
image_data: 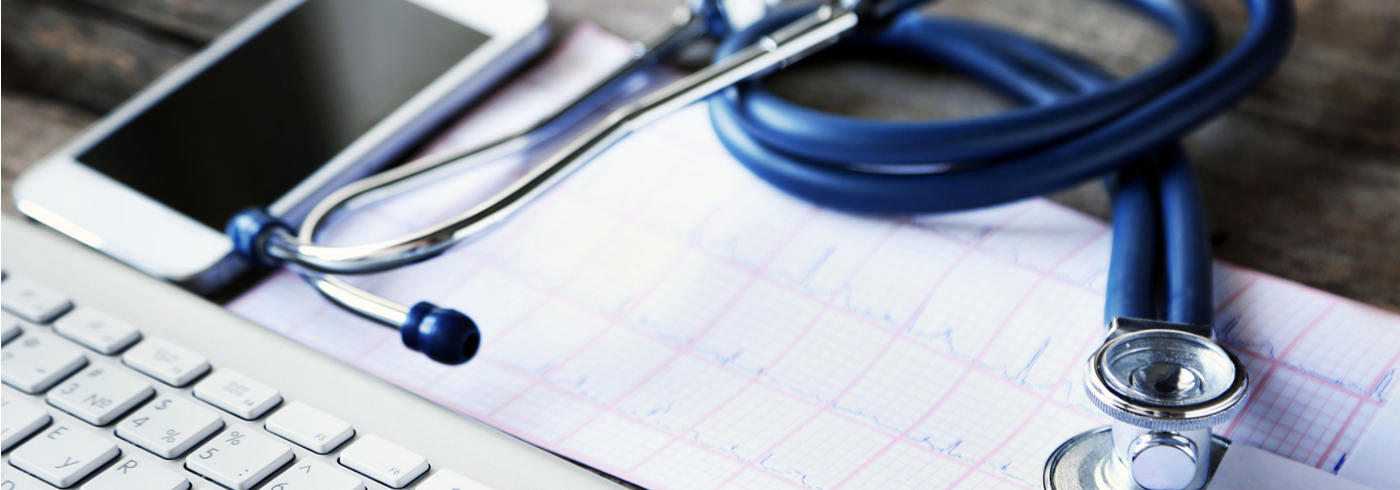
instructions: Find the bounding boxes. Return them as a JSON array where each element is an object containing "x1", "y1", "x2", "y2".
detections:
[{"x1": 46, "y1": 365, "x2": 155, "y2": 426}]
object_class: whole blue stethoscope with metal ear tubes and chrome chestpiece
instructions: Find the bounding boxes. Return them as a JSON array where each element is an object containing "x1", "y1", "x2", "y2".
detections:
[{"x1": 228, "y1": 0, "x2": 1294, "y2": 490}]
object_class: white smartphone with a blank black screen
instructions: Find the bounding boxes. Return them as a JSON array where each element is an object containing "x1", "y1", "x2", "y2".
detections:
[{"x1": 13, "y1": 0, "x2": 547, "y2": 293}]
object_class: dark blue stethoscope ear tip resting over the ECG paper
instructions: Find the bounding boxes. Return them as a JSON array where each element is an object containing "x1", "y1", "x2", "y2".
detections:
[{"x1": 399, "y1": 301, "x2": 482, "y2": 365}]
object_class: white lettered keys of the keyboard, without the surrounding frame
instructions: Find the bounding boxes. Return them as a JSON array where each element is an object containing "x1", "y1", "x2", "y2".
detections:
[{"x1": 0, "y1": 274, "x2": 472, "y2": 490}]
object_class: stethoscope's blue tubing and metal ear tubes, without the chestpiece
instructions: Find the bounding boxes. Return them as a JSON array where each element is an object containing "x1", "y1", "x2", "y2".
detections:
[{"x1": 228, "y1": 0, "x2": 1292, "y2": 372}]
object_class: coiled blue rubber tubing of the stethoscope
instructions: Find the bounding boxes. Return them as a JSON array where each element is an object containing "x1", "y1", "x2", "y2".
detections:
[{"x1": 708, "y1": 0, "x2": 1294, "y2": 325}]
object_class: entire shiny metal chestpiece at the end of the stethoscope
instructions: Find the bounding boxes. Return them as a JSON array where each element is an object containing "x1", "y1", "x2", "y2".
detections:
[{"x1": 1044, "y1": 318, "x2": 1249, "y2": 490}]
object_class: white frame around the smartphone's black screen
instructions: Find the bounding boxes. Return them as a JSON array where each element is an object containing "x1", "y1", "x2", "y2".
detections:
[{"x1": 13, "y1": 0, "x2": 547, "y2": 290}]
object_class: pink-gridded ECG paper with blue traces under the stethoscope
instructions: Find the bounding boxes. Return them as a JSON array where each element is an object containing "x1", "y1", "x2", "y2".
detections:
[{"x1": 230, "y1": 27, "x2": 1400, "y2": 490}]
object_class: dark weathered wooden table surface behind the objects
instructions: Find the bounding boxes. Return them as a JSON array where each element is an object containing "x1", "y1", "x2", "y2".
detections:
[{"x1": 0, "y1": 0, "x2": 1400, "y2": 317}]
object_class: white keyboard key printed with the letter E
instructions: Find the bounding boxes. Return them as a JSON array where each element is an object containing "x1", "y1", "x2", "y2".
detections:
[{"x1": 10, "y1": 422, "x2": 122, "y2": 489}]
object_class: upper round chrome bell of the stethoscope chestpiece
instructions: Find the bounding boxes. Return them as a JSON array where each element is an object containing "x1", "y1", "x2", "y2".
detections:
[{"x1": 1085, "y1": 330, "x2": 1249, "y2": 431}]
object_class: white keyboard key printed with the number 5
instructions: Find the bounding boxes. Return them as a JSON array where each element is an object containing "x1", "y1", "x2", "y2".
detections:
[{"x1": 185, "y1": 426, "x2": 291, "y2": 490}]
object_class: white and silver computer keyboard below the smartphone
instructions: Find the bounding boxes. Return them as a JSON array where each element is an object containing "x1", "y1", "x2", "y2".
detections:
[{"x1": 0, "y1": 217, "x2": 617, "y2": 490}]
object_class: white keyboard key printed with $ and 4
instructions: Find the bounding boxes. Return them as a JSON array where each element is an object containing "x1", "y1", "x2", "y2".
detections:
[{"x1": 116, "y1": 395, "x2": 224, "y2": 459}]
